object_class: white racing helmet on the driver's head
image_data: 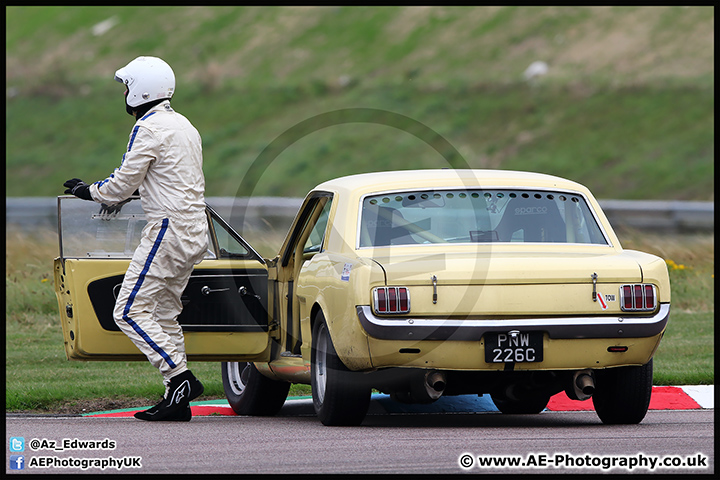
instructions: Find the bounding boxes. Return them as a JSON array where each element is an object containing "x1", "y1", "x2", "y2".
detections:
[{"x1": 115, "y1": 57, "x2": 175, "y2": 107}]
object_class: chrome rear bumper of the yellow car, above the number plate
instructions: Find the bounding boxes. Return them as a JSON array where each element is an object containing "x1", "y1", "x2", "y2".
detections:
[{"x1": 356, "y1": 303, "x2": 670, "y2": 341}]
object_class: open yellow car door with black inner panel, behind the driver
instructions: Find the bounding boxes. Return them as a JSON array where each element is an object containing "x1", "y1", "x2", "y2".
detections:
[{"x1": 54, "y1": 196, "x2": 272, "y2": 362}]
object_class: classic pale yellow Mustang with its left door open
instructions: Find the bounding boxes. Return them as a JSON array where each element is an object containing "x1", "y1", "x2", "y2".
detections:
[{"x1": 55, "y1": 169, "x2": 670, "y2": 425}]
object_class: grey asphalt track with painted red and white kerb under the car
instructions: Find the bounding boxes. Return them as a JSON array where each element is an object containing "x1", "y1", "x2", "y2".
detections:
[{"x1": 6, "y1": 387, "x2": 714, "y2": 474}]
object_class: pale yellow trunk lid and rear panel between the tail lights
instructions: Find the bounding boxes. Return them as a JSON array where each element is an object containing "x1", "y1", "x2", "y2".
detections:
[{"x1": 374, "y1": 250, "x2": 642, "y2": 317}]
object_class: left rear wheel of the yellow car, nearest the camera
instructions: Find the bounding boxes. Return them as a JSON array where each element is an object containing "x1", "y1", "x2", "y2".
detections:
[{"x1": 311, "y1": 313, "x2": 370, "y2": 426}]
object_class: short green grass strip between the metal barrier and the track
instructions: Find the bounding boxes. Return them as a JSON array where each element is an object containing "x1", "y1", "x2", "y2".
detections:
[{"x1": 5, "y1": 231, "x2": 714, "y2": 413}]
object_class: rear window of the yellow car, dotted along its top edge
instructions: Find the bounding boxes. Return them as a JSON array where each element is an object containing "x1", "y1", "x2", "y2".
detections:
[{"x1": 359, "y1": 189, "x2": 608, "y2": 247}]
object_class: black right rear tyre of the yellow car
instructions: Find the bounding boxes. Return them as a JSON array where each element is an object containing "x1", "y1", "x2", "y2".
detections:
[{"x1": 592, "y1": 359, "x2": 653, "y2": 424}]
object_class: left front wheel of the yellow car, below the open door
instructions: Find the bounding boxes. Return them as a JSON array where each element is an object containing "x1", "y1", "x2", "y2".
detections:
[{"x1": 221, "y1": 362, "x2": 290, "y2": 416}]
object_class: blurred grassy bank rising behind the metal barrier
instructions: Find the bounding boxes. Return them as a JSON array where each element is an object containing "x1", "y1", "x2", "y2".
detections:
[{"x1": 6, "y1": 7, "x2": 714, "y2": 200}]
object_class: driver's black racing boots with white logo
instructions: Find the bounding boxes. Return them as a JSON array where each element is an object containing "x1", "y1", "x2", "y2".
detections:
[{"x1": 135, "y1": 370, "x2": 205, "y2": 422}]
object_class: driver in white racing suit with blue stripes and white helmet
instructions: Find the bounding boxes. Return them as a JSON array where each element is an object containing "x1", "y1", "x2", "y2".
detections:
[{"x1": 64, "y1": 56, "x2": 208, "y2": 421}]
